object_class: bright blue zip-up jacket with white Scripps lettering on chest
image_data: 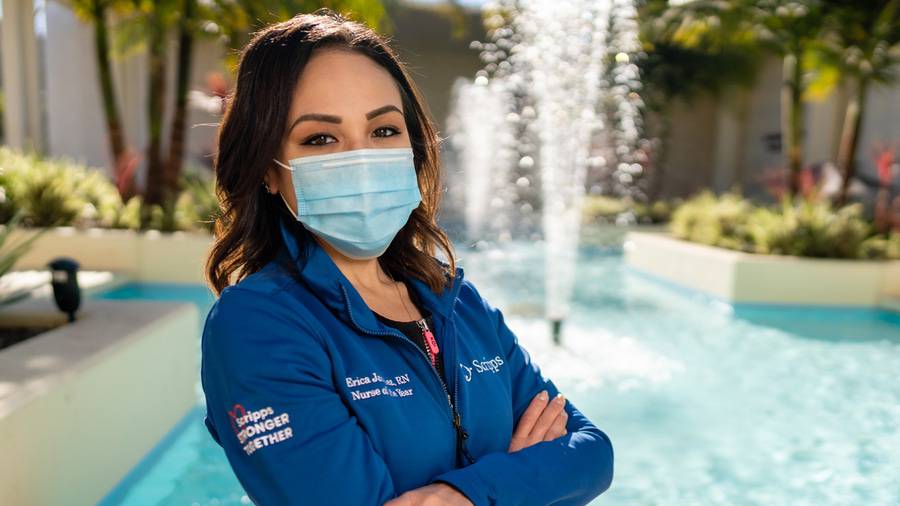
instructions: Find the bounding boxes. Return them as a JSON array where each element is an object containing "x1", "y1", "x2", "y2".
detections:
[{"x1": 201, "y1": 215, "x2": 613, "y2": 506}]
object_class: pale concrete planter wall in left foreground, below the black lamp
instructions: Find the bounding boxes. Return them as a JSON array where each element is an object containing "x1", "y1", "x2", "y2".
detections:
[{"x1": 0, "y1": 300, "x2": 200, "y2": 505}]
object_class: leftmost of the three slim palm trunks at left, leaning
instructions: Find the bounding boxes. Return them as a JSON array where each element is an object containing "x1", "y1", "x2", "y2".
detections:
[{"x1": 91, "y1": 1, "x2": 130, "y2": 194}]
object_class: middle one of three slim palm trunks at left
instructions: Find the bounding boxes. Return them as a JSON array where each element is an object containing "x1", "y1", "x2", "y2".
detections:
[{"x1": 144, "y1": 13, "x2": 169, "y2": 211}]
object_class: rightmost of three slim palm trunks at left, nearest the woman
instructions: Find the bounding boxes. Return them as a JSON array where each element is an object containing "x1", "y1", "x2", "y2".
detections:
[{"x1": 165, "y1": 0, "x2": 196, "y2": 198}]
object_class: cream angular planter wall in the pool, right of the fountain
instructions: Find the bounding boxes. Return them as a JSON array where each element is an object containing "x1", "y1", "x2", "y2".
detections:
[{"x1": 625, "y1": 232, "x2": 900, "y2": 306}]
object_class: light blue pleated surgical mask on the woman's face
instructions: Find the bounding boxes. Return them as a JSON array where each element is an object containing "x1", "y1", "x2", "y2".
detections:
[{"x1": 275, "y1": 148, "x2": 422, "y2": 259}]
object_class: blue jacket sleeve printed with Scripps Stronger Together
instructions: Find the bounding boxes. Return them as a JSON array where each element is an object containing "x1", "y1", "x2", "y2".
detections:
[{"x1": 201, "y1": 287, "x2": 396, "y2": 506}]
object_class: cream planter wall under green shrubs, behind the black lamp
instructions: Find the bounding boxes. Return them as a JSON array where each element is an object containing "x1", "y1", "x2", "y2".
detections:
[{"x1": 12, "y1": 227, "x2": 213, "y2": 284}]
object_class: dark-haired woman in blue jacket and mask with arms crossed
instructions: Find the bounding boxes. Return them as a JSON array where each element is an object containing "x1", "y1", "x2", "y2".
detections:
[{"x1": 202, "y1": 10, "x2": 613, "y2": 506}]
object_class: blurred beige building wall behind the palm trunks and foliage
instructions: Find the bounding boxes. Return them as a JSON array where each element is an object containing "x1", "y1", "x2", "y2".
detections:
[{"x1": 26, "y1": 2, "x2": 900, "y2": 202}]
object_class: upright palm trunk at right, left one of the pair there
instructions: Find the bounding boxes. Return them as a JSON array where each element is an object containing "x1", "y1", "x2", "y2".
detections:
[{"x1": 781, "y1": 52, "x2": 803, "y2": 198}]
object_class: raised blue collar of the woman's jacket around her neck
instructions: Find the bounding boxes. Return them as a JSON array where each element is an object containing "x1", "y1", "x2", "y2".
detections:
[{"x1": 279, "y1": 211, "x2": 463, "y2": 331}]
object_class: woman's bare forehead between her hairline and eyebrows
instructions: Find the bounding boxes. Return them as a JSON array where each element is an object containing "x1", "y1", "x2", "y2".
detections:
[{"x1": 291, "y1": 48, "x2": 403, "y2": 115}]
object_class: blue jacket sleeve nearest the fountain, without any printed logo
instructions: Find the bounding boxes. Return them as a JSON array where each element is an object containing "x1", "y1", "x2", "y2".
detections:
[{"x1": 431, "y1": 281, "x2": 613, "y2": 506}]
